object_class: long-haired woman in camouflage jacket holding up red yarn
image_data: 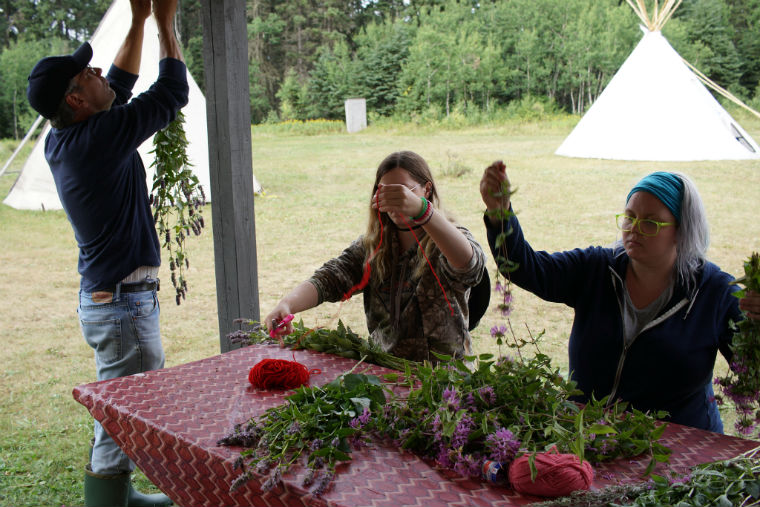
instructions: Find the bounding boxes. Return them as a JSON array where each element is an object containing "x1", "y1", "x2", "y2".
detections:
[{"x1": 265, "y1": 151, "x2": 486, "y2": 362}]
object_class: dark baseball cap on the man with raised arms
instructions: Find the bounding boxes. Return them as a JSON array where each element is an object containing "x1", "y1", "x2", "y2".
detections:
[{"x1": 26, "y1": 42, "x2": 92, "y2": 119}]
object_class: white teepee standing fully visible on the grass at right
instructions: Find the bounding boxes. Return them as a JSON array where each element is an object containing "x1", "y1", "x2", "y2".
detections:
[{"x1": 555, "y1": 0, "x2": 760, "y2": 161}]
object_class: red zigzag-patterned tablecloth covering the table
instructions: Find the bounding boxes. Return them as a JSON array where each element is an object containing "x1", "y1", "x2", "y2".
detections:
[{"x1": 73, "y1": 345, "x2": 760, "y2": 507}]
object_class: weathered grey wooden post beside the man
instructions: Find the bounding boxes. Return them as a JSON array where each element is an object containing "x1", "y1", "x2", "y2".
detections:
[{"x1": 201, "y1": 0, "x2": 259, "y2": 352}]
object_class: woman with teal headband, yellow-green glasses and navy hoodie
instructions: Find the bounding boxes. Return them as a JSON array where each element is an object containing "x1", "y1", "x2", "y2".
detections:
[{"x1": 480, "y1": 162, "x2": 760, "y2": 433}]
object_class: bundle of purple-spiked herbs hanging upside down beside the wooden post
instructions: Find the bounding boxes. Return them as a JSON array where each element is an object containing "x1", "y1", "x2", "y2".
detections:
[{"x1": 151, "y1": 111, "x2": 206, "y2": 305}]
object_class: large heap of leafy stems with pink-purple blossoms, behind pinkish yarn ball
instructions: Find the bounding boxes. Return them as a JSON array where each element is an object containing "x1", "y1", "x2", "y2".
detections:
[{"x1": 381, "y1": 339, "x2": 670, "y2": 477}]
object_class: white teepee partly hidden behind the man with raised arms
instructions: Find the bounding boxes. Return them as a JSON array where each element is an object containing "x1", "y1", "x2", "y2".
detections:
[{"x1": 3, "y1": 0, "x2": 261, "y2": 210}]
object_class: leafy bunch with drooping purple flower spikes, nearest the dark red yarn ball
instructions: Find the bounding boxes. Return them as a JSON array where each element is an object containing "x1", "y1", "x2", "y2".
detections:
[{"x1": 218, "y1": 372, "x2": 385, "y2": 496}]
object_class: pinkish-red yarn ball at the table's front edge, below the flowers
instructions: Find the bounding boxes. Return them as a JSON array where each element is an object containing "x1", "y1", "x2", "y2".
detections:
[{"x1": 509, "y1": 452, "x2": 594, "y2": 497}]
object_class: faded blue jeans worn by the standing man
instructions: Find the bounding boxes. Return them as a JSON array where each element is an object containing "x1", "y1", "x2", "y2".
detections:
[{"x1": 77, "y1": 290, "x2": 164, "y2": 475}]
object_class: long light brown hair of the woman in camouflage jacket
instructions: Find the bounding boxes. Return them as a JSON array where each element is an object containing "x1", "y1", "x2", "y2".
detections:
[{"x1": 363, "y1": 151, "x2": 449, "y2": 280}]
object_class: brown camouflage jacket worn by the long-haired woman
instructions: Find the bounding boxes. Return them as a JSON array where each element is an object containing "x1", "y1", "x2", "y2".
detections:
[{"x1": 309, "y1": 227, "x2": 486, "y2": 362}]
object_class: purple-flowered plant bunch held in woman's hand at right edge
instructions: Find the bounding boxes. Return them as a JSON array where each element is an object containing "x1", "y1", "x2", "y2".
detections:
[{"x1": 715, "y1": 253, "x2": 760, "y2": 435}]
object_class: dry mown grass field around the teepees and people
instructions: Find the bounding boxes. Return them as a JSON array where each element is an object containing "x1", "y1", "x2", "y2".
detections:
[{"x1": 0, "y1": 117, "x2": 760, "y2": 506}]
